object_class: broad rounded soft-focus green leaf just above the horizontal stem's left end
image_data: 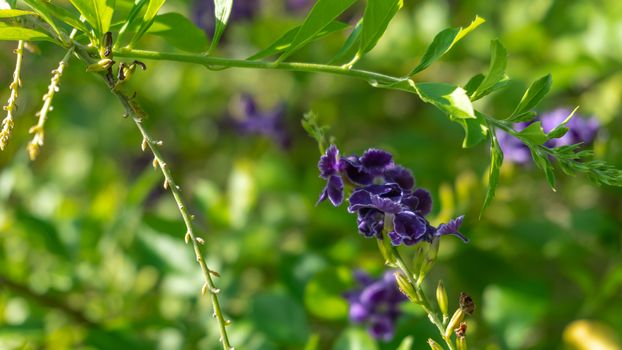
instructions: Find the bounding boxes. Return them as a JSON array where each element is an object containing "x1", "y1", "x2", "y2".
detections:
[{"x1": 149, "y1": 12, "x2": 209, "y2": 52}]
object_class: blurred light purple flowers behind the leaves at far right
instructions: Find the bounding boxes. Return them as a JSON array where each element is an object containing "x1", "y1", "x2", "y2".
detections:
[{"x1": 497, "y1": 108, "x2": 600, "y2": 164}]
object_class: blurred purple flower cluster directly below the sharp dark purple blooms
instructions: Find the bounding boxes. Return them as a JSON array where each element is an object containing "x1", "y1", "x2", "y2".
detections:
[{"x1": 345, "y1": 271, "x2": 407, "y2": 341}]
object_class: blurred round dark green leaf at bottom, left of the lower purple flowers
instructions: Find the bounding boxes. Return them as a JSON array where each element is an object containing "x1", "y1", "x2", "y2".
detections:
[{"x1": 251, "y1": 293, "x2": 309, "y2": 345}]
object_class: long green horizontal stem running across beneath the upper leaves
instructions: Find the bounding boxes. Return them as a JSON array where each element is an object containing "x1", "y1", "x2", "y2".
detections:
[{"x1": 114, "y1": 49, "x2": 407, "y2": 84}]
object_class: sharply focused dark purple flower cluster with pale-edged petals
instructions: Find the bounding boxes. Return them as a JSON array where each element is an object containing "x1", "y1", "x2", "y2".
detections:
[{"x1": 318, "y1": 145, "x2": 468, "y2": 246}]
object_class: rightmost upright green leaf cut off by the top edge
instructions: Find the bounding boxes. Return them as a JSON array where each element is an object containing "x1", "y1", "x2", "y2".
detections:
[{"x1": 357, "y1": 0, "x2": 404, "y2": 55}]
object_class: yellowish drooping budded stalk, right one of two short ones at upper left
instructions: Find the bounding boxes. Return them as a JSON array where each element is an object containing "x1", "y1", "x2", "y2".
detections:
[{"x1": 28, "y1": 29, "x2": 78, "y2": 160}]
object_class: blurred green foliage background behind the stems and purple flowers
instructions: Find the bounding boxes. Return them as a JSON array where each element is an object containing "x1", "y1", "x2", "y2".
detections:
[{"x1": 0, "y1": 0, "x2": 622, "y2": 350}]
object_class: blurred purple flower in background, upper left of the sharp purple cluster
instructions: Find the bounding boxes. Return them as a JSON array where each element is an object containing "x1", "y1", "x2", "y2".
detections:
[{"x1": 230, "y1": 95, "x2": 290, "y2": 148}]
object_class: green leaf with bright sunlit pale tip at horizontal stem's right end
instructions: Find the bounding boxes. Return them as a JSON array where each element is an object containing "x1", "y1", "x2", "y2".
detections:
[{"x1": 411, "y1": 82, "x2": 476, "y2": 119}]
